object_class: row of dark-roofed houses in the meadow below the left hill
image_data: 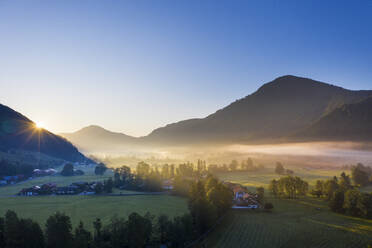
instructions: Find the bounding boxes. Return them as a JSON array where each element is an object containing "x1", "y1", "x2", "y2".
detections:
[{"x1": 18, "y1": 182, "x2": 102, "y2": 196}]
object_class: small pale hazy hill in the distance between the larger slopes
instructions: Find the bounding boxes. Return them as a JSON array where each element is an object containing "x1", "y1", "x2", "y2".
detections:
[{"x1": 60, "y1": 125, "x2": 137, "y2": 151}]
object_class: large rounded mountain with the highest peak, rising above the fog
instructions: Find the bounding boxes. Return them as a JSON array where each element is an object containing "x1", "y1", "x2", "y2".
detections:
[{"x1": 144, "y1": 76, "x2": 372, "y2": 143}]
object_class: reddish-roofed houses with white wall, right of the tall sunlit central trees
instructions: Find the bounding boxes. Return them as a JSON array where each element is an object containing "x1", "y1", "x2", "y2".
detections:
[{"x1": 225, "y1": 182, "x2": 261, "y2": 209}]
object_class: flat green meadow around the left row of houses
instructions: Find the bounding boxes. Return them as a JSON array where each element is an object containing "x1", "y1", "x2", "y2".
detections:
[{"x1": 0, "y1": 169, "x2": 187, "y2": 229}]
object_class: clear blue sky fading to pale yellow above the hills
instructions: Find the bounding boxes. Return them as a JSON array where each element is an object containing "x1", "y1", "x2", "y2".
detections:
[{"x1": 0, "y1": 0, "x2": 372, "y2": 136}]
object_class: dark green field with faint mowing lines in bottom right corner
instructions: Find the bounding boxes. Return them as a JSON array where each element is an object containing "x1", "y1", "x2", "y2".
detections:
[{"x1": 203, "y1": 198, "x2": 372, "y2": 248}]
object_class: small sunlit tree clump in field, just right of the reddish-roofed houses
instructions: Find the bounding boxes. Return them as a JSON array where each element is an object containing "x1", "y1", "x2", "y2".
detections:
[{"x1": 269, "y1": 176, "x2": 309, "y2": 199}]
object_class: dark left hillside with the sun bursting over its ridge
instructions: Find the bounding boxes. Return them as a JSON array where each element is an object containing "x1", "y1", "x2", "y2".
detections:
[{"x1": 0, "y1": 104, "x2": 87, "y2": 162}]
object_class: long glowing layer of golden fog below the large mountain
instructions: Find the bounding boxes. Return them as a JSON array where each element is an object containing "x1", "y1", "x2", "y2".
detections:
[{"x1": 91, "y1": 142, "x2": 372, "y2": 168}]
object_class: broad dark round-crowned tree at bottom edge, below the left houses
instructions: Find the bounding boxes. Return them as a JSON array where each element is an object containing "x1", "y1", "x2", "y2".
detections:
[{"x1": 45, "y1": 212, "x2": 73, "y2": 248}]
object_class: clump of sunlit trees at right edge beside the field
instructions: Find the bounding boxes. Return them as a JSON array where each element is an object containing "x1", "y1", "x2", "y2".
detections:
[{"x1": 311, "y1": 164, "x2": 372, "y2": 219}]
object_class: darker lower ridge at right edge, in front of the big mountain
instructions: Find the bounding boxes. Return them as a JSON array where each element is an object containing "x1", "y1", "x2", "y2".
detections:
[{"x1": 296, "y1": 98, "x2": 372, "y2": 141}]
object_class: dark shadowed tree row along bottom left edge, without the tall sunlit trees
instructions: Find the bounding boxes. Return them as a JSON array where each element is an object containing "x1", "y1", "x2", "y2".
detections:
[{"x1": 0, "y1": 211, "x2": 194, "y2": 248}]
